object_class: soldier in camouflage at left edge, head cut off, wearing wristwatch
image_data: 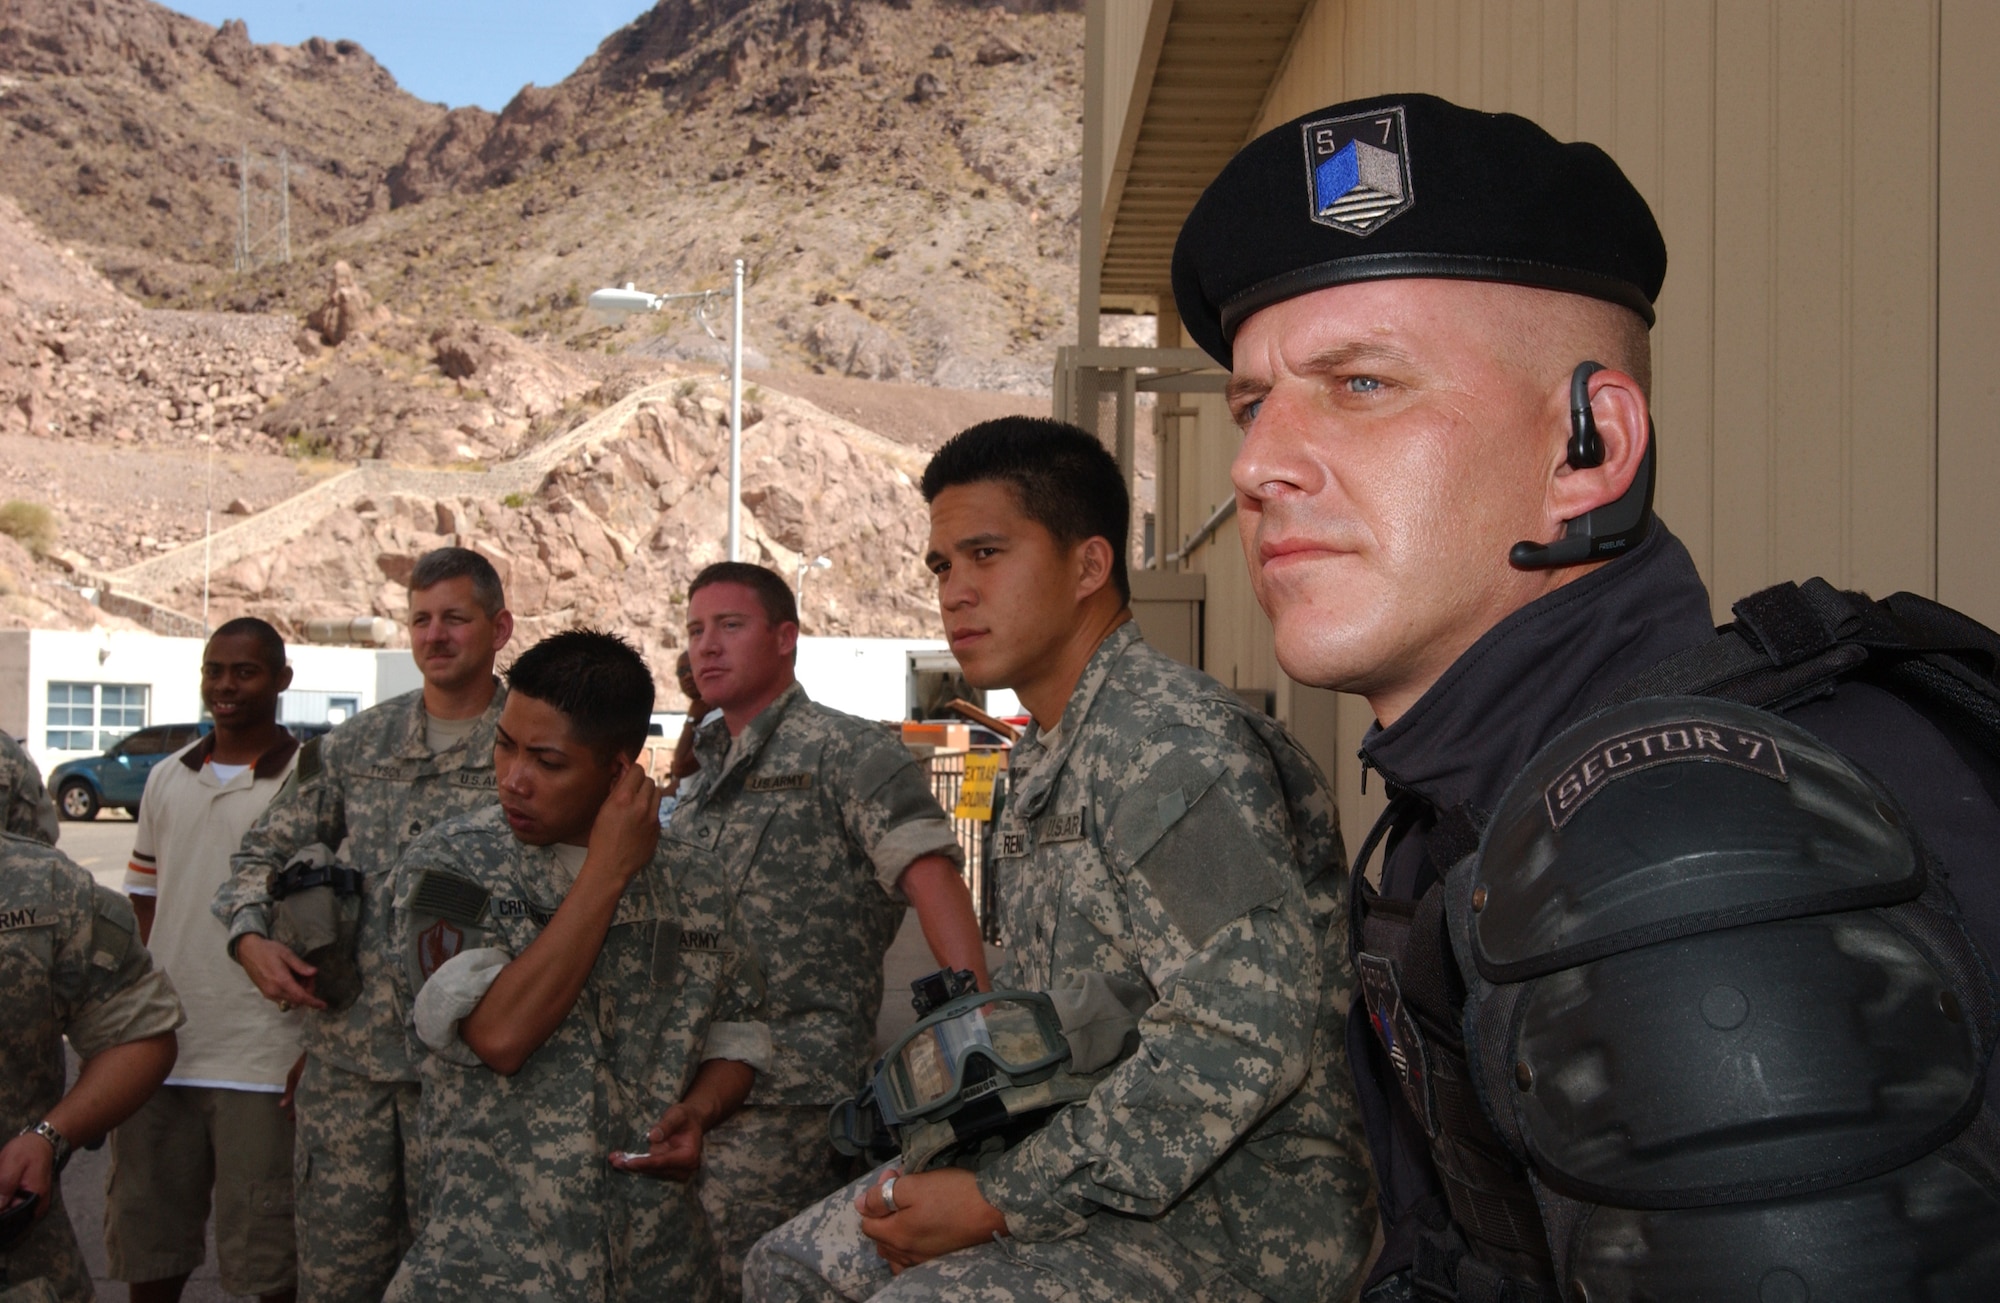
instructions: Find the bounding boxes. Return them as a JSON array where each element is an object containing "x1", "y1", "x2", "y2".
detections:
[{"x1": 0, "y1": 831, "x2": 182, "y2": 1303}]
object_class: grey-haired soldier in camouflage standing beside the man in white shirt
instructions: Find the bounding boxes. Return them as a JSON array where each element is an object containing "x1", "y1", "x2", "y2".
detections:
[{"x1": 214, "y1": 548, "x2": 514, "y2": 1303}]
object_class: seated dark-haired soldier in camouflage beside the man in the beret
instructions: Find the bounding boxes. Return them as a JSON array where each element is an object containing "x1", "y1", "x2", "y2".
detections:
[{"x1": 744, "y1": 418, "x2": 1370, "y2": 1303}]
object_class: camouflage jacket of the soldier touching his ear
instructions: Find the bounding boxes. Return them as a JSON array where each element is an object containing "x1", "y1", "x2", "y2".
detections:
[{"x1": 388, "y1": 805, "x2": 756, "y2": 1303}]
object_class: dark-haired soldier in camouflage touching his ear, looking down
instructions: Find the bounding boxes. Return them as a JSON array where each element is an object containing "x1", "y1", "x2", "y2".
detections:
[{"x1": 388, "y1": 632, "x2": 770, "y2": 1303}]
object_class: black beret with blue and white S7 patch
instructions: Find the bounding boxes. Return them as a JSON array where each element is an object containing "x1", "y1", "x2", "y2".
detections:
[{"x1": 1174, "y1": 94, "x2": 1666, "y2": 366}]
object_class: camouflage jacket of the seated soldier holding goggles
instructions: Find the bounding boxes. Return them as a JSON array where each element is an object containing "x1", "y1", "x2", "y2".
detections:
[{"x1": 978, "y1": 624, "x2": 1374, "y2": 1303}]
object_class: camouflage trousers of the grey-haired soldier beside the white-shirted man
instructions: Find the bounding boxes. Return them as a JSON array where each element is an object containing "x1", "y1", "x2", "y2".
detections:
[{"x1": 292, "y1": 1055, "x2": 422, "y2": 1303}]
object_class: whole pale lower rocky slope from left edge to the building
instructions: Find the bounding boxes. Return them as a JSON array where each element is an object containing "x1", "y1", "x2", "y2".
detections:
[{"x1": 0, "y1": 186, "x2": 1040, "y2": 655}]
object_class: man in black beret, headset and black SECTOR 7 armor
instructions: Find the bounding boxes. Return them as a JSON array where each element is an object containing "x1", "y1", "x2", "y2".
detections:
[{"x1": 1174, "y1": 94, "x2": 2000, "y2": 1301}]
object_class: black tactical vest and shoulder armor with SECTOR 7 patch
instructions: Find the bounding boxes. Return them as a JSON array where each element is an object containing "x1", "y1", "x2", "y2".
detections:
[{"x1": 1350, "y1": 580, "x2": 2000, "y2": 1303}]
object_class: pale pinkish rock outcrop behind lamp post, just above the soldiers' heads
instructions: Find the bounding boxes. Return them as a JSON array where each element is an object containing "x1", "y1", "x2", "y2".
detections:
[{"x1": 160, "y1": 376, "x2": 938, "y2": 667}]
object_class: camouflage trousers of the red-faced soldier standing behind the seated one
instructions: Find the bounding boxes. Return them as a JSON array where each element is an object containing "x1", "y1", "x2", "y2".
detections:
[{"x1": 694, "y1": 1105, "x2": 848, "y2": 1299}]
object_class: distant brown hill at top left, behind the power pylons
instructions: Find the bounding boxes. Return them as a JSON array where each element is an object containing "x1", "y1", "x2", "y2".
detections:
[{"x1": 0, "y1": 0, "x2": 444, "y2": 263}]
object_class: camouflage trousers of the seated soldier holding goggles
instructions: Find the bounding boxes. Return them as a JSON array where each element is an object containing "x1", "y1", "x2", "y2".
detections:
[{"x1": 744, "y1": 1173, "x2": 1258, "y2": 1303}]
